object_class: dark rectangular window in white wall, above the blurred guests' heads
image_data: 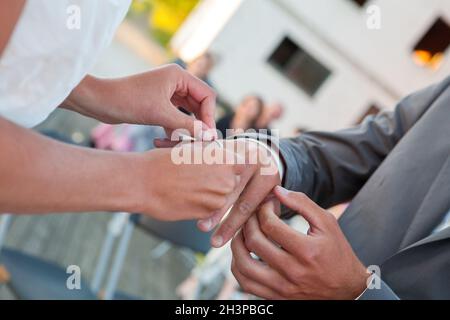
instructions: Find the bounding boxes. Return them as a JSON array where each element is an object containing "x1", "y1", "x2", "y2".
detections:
[{"x1": 268, "y1": 37, "x2": 331, "y2": 96}]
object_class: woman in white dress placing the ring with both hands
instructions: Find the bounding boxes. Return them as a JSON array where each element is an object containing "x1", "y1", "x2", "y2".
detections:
[{"x1": 0, "y1": 0, "x2": 250, "y2": 220}]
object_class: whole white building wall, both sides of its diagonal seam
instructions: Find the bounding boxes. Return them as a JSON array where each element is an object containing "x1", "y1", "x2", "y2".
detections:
[{"x1": 173, "y1": 0, "x2": 450, "y2": 135}]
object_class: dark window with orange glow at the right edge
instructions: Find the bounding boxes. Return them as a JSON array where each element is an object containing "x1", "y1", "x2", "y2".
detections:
[{"x1": 413, "y1": 18, "x2": 450, "y2": 70}]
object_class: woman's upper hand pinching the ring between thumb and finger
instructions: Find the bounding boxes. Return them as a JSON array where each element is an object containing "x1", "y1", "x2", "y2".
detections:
[{"x1": 62, "y1": 65, "x2": 216, "y2": 140}]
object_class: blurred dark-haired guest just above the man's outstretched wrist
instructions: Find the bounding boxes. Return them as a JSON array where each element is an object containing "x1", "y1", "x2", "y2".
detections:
[{"x1": 217, "y1": 95, "x2": 264, "y2": 137}]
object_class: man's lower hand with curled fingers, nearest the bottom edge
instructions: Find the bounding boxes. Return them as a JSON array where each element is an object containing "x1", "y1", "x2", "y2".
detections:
[{"x1": 232, "y1": 187, "x2": 369, "y2": 299}]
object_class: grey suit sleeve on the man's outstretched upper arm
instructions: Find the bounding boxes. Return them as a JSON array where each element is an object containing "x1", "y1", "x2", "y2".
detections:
[{"x1": 280, "y1": 77, "x2": 450, "y2": 212}]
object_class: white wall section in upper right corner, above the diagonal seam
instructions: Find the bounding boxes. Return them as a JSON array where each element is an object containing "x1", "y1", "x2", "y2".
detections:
[{"x1": 279, "y1": 0, "x2": 450, "y2": 96}]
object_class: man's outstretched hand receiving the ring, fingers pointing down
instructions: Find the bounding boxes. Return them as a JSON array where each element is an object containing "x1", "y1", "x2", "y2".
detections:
[{"x1": 198, "y1": 140, "x2": 281, "y2": 247}]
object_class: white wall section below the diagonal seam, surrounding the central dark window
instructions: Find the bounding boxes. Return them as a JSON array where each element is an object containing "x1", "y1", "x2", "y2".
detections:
[{"x1": 207, "y1": 0, "x2": 392, "y2": 135}]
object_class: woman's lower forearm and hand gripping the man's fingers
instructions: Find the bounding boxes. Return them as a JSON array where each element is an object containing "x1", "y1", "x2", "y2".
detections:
[{"x1": 0, "y1": 117, "x2": 239, "y2": 221}]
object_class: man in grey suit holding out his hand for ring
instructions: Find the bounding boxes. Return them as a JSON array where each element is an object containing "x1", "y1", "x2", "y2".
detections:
[{"x1": 205, "y1": 77, "x2": 450, "y2": 299}]
